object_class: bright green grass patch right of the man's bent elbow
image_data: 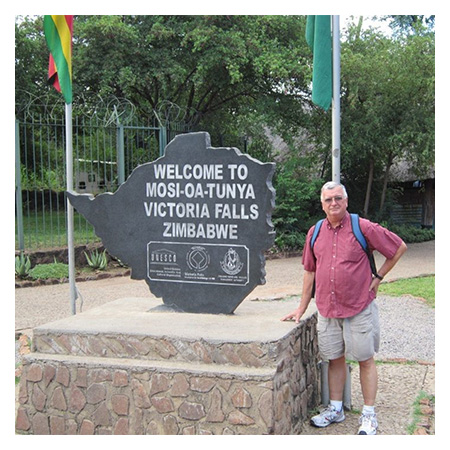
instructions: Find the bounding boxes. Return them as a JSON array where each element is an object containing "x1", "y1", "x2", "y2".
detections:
[{"x1": 378, "y1": 275, "x2": 435, "y2": 308}]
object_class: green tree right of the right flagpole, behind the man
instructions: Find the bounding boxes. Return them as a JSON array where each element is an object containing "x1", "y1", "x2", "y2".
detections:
[{"x1": 341, "y1": 20, "x2": 434, "y2": 215}]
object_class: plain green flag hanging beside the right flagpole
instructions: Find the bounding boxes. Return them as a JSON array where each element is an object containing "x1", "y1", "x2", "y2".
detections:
[{"x1": 306, "y1": 16, "x2": 333, "y2": 111}]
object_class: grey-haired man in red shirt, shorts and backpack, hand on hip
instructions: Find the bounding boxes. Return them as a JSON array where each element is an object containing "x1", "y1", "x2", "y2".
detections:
[{"x1": 282, "y1": 182, "x2": 407, "y2": 434}]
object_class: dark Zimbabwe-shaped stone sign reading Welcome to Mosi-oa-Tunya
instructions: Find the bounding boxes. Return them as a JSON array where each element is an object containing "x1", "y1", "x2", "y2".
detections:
[{"x1": 68, "y1": 132, "x2": 275, "y2": 314}]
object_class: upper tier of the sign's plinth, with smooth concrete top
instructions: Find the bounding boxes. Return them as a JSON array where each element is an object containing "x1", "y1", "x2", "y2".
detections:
[{"x1": 33, "y1": 298, "x2": 312, "y2": 368}]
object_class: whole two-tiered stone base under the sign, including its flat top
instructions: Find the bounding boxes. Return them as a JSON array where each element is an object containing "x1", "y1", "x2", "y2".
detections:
[{"x1": 16, "y1": 298, "x2": 320, "y2": 435}]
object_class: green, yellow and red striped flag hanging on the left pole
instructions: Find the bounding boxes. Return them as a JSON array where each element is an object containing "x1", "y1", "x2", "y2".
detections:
[{"x1": 44, "y1": 16, "x2": 73, "y2": 104}]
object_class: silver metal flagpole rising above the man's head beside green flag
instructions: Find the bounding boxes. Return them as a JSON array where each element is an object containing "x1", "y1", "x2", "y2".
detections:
[{"x1": 331, "y1": 16, "x2": 341, "y2": 183}]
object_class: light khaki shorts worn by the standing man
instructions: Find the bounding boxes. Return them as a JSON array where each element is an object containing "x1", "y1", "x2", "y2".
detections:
[{"x1": 317, "y1": 301, "x2": 380, "y2": 361}]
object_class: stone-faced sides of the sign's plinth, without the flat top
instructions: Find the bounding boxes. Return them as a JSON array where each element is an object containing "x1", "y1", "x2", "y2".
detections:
[{"x1": 16, "y1": 300, "x2": 320, "y2": 434}]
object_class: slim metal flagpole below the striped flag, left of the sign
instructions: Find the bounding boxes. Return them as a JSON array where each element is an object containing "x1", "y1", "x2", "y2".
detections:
[{"x1": 65, "y1": 103, "x2": 77, "y2": 314}]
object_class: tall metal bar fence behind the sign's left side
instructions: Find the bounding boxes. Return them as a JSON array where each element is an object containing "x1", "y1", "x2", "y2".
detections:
[{"x1": 15, "y1": 113, "x2": 167, "y2": 251}]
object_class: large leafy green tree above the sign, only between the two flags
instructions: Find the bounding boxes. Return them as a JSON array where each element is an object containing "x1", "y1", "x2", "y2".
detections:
[{"x1": 74, "y1": 16, "x2": 307, "y2": 131}]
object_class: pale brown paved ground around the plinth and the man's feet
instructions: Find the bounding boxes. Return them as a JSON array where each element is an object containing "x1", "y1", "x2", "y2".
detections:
[{"x1": 15, "y1": 241, "x2": 435, "y2": 435}]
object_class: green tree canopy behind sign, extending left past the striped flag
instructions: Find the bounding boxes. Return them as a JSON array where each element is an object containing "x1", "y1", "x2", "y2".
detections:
[{"x1": 16, "y1": 16, "x2": 311, "y2": 153}]
